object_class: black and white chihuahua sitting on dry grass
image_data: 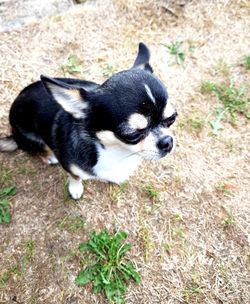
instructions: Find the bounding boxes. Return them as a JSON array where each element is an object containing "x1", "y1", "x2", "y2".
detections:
[{"x1": 0, "y1": 43, "x2": 177, "y2": 199}]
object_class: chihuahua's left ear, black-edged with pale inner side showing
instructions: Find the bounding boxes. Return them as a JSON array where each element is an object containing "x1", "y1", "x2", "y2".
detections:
[{"x1": 41, "y1": 75, "x2": 88, "y2": 119}]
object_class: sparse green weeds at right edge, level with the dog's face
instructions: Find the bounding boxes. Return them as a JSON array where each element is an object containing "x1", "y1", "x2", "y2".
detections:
[{"x1": 201, "y1": 79, "x2": 250, "y2": 135}]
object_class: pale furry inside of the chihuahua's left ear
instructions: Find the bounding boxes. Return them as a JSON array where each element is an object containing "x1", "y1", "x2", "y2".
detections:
[{"x1": 48, "y1": 83, "x2": 88, "y2": 119}]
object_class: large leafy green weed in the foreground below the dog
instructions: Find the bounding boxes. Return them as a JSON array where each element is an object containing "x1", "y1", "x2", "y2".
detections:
[{"x1": 75, "y1": 230, "x2": 141, "y2": 304}]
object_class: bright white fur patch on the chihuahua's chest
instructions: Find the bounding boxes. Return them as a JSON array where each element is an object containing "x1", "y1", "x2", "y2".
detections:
[{"x1": 93, "y1": 146, "x2": 140, "y2": 184}]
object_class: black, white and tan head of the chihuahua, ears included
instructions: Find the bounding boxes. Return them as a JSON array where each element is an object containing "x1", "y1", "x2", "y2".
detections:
[{"x1": 42, "y1": 43, "x2": 177, "y2": 159}]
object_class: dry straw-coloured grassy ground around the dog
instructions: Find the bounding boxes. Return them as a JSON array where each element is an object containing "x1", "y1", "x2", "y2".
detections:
[{"x1": 0, "y1": 0, "x2": 250, "y2": 304}]
